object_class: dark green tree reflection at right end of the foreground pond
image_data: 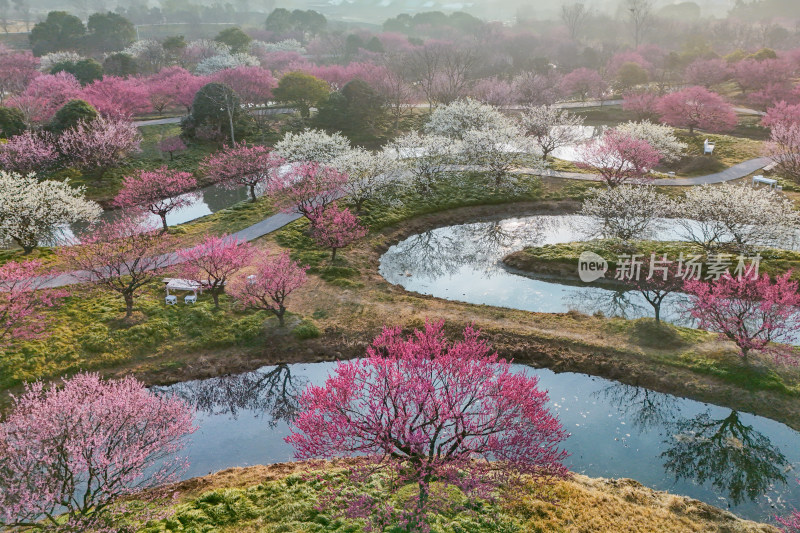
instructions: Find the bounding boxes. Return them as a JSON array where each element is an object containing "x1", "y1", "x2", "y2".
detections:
[{"x1": 661, "y1": 411, "x2": 789, "y2": 505}]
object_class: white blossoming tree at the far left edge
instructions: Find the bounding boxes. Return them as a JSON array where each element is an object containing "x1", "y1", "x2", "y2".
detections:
[{"x1": 0, "y1": 171, "x2": 103, "y2": 253}]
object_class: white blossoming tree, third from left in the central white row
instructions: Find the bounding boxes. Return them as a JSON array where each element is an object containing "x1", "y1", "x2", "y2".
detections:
[{"x1": 389, "y1": 131, "x2": 463, "y2": 192}]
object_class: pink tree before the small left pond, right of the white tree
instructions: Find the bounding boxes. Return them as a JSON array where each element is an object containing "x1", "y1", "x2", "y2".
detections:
[{"x1": 114, "y1": 166, "x2": 198, "y2": 232}]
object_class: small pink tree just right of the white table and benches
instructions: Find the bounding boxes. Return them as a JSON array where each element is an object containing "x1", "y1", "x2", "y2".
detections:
[{"x1": 178, "y1": 235, "x2": 253, "y2": 308}]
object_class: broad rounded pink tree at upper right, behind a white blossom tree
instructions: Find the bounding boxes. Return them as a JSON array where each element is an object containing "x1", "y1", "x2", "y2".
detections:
[{"x1": 657, "y1": 87, "x2": 737, "y2": 134}]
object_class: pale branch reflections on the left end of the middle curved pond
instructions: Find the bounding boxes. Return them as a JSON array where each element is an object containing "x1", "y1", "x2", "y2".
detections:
[{"x1": 382, "y1": 217, "x2": 554, "y2": 281}]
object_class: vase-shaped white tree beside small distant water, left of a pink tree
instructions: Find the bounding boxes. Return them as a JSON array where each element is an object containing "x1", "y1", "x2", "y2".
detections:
[{"x1": 520, "y1": 105, "x2": 583, "y2": 161}]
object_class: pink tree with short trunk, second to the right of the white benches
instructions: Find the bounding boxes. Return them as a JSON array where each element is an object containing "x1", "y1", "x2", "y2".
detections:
[{"x1": 228, "y1": 250, "x2": 307, "y2": 327}]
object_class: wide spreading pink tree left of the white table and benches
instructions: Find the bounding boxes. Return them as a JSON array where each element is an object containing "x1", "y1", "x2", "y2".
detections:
[{"x1": 58, "y1": 216, "x2": 176, "y2": 318}]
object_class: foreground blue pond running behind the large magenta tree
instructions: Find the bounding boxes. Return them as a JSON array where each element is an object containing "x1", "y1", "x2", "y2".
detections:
[{"x1": 157, "y1": 363, "x2": 800, "y2": 521}]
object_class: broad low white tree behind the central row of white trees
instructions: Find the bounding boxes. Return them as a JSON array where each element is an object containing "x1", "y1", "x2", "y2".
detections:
[{"x1": 425, "y1": 98, "x2": 513, "y2": 139}]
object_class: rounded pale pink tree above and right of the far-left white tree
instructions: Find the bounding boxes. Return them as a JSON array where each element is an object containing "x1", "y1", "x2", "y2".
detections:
[{"x1": 58, "y1": 117, "x2": 141, "y2": 171}]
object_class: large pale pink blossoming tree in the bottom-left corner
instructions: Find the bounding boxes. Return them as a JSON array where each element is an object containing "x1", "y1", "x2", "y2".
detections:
[{"x1": 0, "y1": 374, "x2": 196, "y2": 531}]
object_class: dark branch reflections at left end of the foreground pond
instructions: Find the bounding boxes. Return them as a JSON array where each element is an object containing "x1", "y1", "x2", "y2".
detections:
[{"x1": 163, "y1": 364, "x2": 308, "y2": 427}]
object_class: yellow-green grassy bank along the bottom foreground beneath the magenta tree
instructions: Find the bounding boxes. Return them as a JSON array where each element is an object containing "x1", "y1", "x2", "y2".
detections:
[{"x1": 120, "y1": 461, "x2": 777, "y2": 533}]
